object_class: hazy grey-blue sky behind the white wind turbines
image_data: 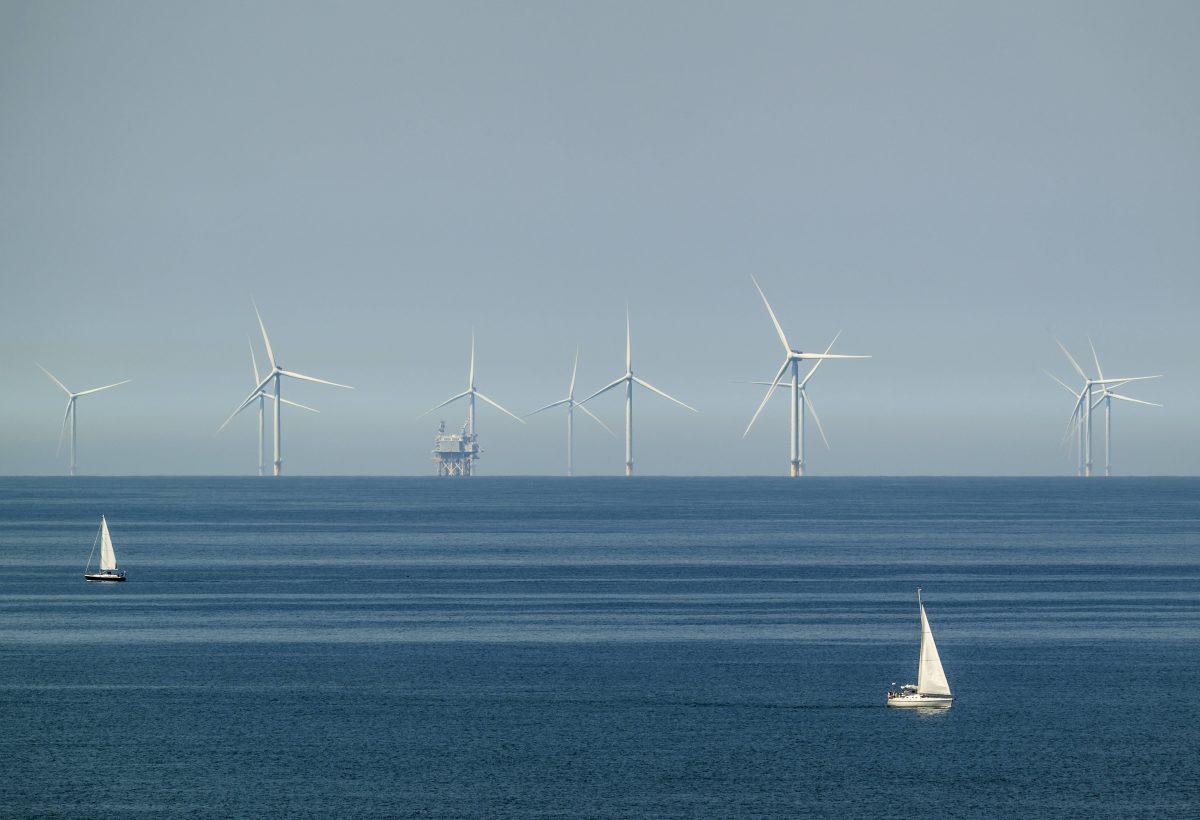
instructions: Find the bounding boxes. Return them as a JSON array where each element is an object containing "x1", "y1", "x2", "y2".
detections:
[{"x1": 0, "y1": 0, "x2": 1200, "y2": 475}]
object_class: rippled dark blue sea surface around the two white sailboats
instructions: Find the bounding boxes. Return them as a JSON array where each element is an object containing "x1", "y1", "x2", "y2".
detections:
[{"x1": 0, "y1": 478, "x2": 1200, "y2": 820}]
